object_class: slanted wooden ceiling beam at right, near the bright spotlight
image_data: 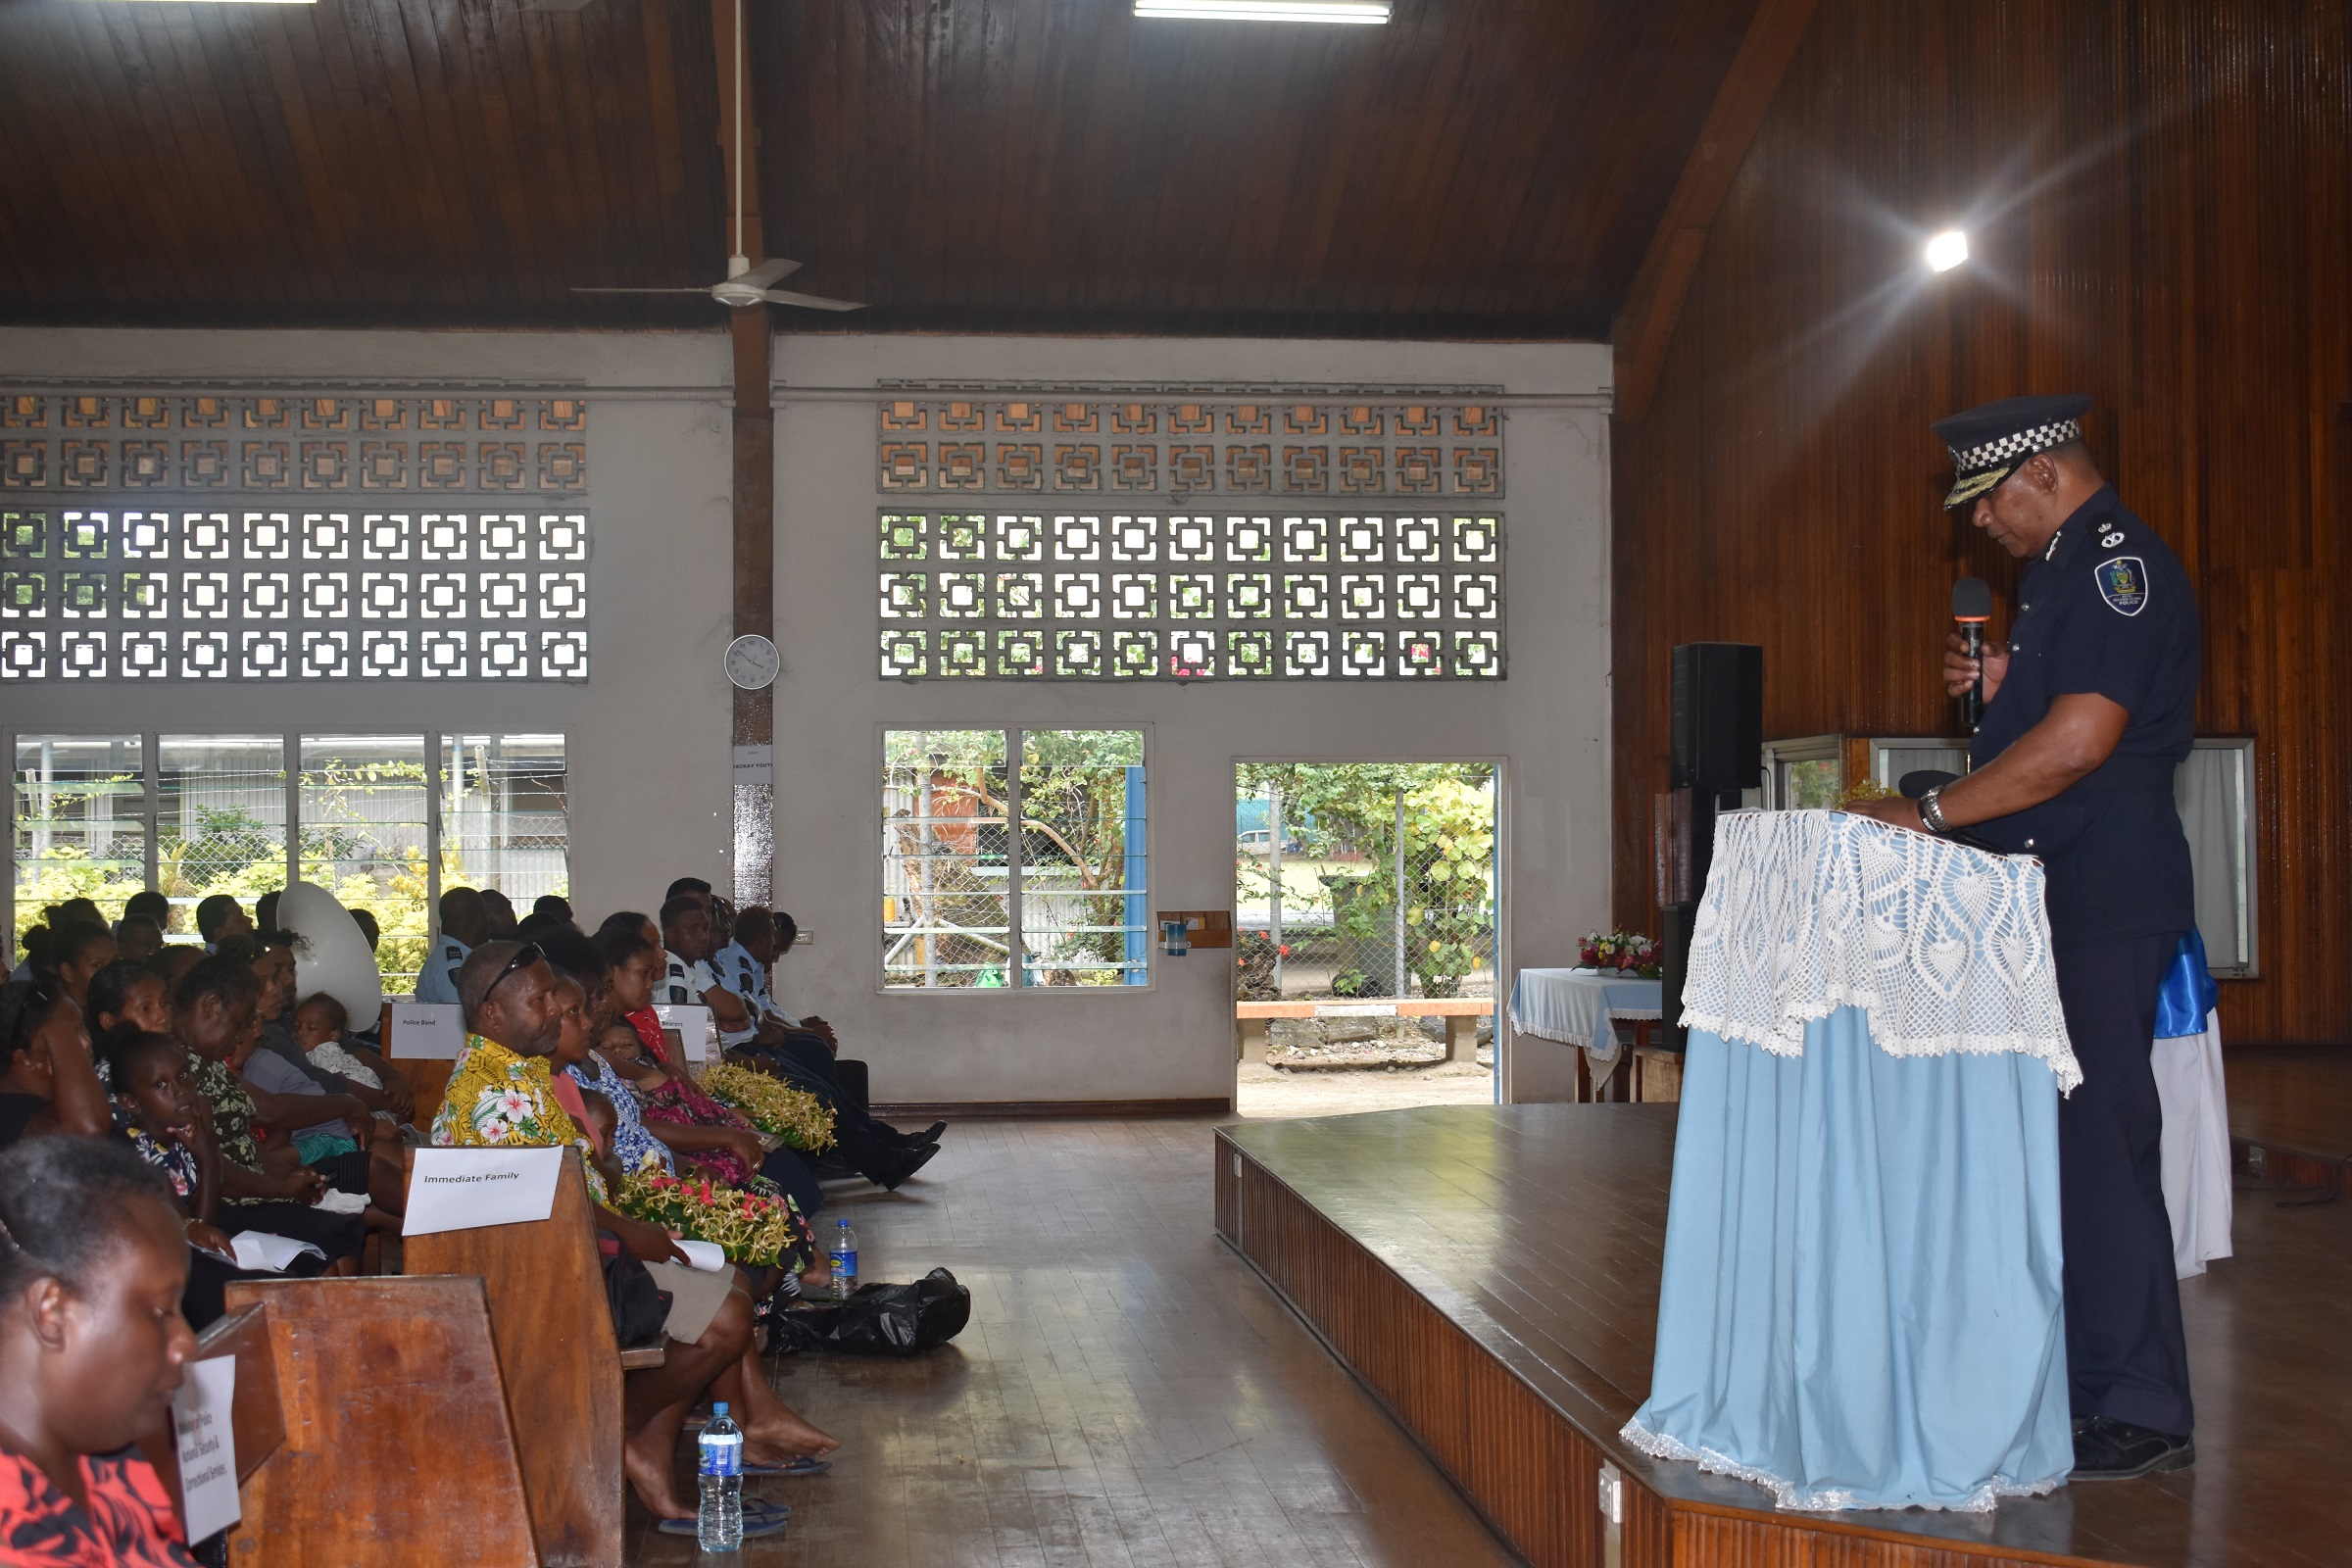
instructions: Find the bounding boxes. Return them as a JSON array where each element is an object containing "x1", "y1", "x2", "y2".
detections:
[{"x1": 1609, "y1": 0, "x2": 1818, "y2": 423}]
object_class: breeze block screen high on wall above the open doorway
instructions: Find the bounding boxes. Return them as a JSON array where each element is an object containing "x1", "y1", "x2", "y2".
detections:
[{"x1": 877, "y1": 393, "x2": 1505, "y2": 679}]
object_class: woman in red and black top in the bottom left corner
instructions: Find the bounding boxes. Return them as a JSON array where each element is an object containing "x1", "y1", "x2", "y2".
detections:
[{"x1": 0, "y1": 1138, "x2": 195, "y2": 1568}]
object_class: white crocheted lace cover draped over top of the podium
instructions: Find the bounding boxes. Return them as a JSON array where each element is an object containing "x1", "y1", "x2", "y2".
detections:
[{"x1": 1682, "y1": 811, "x2": 2082, "y2": 1091}]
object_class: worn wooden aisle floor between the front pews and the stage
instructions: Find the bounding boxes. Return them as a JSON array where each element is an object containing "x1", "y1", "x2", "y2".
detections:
[{"x1": 630, "y1": 1119, "x2": 1510, "y2": 1568}]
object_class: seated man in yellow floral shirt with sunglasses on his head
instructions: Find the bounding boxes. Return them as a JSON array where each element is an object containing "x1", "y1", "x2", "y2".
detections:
[{"x1": 433, "y1": 941, "x2": 835, "y2": 1535}]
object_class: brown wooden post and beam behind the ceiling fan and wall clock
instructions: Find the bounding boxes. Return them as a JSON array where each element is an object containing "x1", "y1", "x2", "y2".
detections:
[{"x1": 710, "y1": 0, "x2": 776, "y2": 907}]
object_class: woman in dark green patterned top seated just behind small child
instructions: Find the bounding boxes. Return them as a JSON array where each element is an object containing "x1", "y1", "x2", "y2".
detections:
[{"x1": 172, "y1": 956, "x2": 367, "y2": 1274}]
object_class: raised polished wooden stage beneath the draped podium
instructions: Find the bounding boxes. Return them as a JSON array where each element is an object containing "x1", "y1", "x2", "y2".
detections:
[{"x1": 1216, "y1": 1104, "x2": 2352, "y2": 1568}]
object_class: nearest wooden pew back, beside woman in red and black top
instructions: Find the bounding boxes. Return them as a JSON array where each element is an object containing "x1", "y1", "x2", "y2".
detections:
[{"x1": 141, "y1": 1279, "x2": 541, "y2": 1568}]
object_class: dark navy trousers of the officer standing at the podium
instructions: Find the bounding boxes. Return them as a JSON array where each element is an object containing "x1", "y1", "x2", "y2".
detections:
[{"x1": 2056, "y1": 931, "x2": 2197, "y2": 1434}]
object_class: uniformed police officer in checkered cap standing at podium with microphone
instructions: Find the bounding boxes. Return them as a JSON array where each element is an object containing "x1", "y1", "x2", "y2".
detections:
[{"x1": 1856, "y1": 397, "x2": 2199, "y2": 1481}]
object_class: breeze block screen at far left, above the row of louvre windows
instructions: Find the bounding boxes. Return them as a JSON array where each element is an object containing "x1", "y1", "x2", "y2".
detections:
[{"x1": 0, "y1": 390, "x2": 588, "y2": 682}]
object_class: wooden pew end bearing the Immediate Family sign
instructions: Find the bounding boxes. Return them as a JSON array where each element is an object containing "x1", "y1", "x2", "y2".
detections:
[{"x1": 400, "y1": 1150, "x2": 630, "y2": 1568}]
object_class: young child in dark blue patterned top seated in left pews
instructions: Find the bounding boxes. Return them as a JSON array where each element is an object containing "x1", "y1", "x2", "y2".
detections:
[{"x1": 106, "y1": 1027, "x2": 327, "y2": 1328}]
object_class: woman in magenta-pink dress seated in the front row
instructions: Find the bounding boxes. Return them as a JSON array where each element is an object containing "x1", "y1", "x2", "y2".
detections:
[{"x1": 595, "y1": 931, "x2": 825, "y2": 1215}]
